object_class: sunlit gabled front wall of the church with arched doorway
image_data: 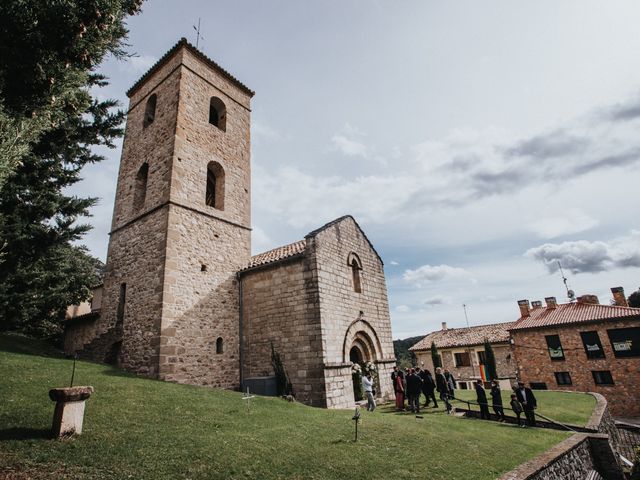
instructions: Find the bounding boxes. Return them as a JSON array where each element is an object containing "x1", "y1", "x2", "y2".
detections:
[{"x1": 307, "y1": 217, "x2": 395, "y2": 408}]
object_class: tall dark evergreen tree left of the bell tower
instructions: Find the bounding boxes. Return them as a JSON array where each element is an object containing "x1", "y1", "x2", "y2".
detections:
[{"x1": 0, "y1": 0, "x2": 142, "y2": 338}]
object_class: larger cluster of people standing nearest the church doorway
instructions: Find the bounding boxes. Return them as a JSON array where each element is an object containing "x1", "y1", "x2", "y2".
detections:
[{"x1": 391, "y1": 367, "x2": 455, "y2": 413}]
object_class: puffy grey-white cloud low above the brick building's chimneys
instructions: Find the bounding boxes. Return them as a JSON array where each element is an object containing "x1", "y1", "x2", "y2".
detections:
[{"x1": 525, "y1": 230, "x2": 640, "y2": 274}]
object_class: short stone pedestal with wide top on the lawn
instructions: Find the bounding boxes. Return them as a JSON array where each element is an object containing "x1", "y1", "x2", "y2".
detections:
[{"x1": 49, "y1": 387, "x2": 93, "y2": 437}]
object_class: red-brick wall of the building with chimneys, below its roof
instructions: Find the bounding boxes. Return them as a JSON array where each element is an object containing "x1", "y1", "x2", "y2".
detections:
[{"x1": 511, "y1": 320, "x2": 640, "y2": 417}]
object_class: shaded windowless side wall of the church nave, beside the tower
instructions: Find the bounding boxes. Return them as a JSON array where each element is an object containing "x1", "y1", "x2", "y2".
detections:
[{"x1": 242, "y1": 258, "x2": 326, "y2": 407}]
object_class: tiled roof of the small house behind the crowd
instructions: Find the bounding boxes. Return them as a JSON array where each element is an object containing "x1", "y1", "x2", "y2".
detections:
[{"x1": 409, "y1": 322, "x2": 515, "y2": 352}]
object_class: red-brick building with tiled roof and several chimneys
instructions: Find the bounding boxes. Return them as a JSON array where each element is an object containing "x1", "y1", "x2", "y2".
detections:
[{"x1": 510, "y1": 287, "x2": 640, "y2": 417}]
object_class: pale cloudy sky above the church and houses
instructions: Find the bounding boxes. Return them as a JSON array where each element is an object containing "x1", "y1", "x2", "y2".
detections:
[{"x1": 74, "y1": 0, "x2": 640, "y2": 338}]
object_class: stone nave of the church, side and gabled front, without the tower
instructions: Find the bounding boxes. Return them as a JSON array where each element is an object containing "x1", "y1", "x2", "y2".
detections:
[{"x1": 242, "y1": 217, "x2": 395, "y2": 408}]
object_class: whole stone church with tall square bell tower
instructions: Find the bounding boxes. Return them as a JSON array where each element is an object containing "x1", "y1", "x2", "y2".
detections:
[{"x1": 65, "y1": 39, "x2": 395, "y2": 408}]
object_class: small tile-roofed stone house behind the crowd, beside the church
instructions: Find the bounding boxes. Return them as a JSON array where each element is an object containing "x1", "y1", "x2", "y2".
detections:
[{"x1": 409, "y1": 322, "x2": 516, "y2": 389}]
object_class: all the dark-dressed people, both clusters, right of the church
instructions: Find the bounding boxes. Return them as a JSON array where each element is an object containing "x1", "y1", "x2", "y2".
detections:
[{"x1": 390, "y1": 367, "x2": 538, "y2": 427}]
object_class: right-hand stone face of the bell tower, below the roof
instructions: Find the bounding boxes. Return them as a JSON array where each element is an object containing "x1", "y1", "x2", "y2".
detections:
[{"x1": 159, "y1": 45, "x2": 251, "y2": 388}]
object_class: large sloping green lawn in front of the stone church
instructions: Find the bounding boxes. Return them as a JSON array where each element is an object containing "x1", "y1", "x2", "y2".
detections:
[{"x1": 0, "y1": 335, "x2": 575, "y2": 480}]
